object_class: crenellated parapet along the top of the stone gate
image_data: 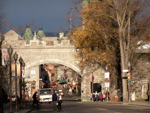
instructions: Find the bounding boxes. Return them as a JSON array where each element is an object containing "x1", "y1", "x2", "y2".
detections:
[{"x1": 3, "y1": 30, "x2": 74, "y2": 48}]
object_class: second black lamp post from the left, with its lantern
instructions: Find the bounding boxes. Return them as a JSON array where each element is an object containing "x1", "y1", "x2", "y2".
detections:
[{"x1": 13, "y1": 52, "x2": 18, "y2": 111}]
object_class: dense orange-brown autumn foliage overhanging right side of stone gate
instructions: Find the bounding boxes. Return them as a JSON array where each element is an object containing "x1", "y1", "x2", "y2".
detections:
[{"x1": 72, "y1": 0, "x2": 118, "y2": 67}]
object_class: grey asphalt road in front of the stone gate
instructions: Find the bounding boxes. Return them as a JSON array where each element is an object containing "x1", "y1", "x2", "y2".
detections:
[{"x1": 31, "y1": 101, "x2": 150, "y2": 113}]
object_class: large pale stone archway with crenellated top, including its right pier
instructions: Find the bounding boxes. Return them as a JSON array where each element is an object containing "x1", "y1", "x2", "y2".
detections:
[{"x1": 2, "y1": 30, "x2": 104, "y2": 101}]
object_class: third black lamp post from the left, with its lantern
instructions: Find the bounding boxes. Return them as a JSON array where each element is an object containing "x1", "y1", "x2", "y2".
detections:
[{"x1": 19, "y1": 57, "x2": 23, "y2": 109}]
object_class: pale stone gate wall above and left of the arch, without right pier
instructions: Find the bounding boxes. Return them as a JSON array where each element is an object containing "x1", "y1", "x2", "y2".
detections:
[{"x1": 2, "y1": 30, "x2": 80, "y2": 96}]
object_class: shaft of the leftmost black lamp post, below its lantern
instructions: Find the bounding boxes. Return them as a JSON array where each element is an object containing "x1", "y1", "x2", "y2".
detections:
[{"x1": 9, "y1": 55, "x2": 13, "y2": 113}]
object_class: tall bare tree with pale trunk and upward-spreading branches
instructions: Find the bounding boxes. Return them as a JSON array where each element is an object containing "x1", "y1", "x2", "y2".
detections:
[{"x1": 101, "y1": 0, "x2": 150, "y2": 101}]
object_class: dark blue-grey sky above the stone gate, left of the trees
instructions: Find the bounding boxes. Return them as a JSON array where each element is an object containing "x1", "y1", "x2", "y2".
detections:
[{"x1": 3, "y1": 0, "x2": 77, "y2": 32}]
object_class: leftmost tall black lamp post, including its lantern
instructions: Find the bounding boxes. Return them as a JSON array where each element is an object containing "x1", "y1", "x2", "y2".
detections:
[{"x1": 8, "y1": 46, "x2": 13, "y2": 113}]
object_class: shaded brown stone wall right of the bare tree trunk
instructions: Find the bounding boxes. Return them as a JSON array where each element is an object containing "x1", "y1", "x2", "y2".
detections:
[{"x1": 131, "y1": 53, "x2": 150, "y2": 99}]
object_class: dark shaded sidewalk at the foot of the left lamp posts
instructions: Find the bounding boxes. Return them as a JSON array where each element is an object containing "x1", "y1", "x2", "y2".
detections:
[{"x1": 3, "y1": 102, "x2": 32, "y2": 113}]
